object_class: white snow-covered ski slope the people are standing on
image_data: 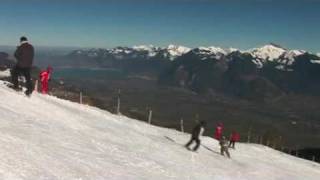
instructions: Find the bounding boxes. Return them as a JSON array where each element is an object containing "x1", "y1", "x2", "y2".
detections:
[{"x1": 0, "y1": 81, "x2": 320, "y2": 180}]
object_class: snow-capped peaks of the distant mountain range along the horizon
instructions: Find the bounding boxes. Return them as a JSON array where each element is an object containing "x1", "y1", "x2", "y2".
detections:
[{"x1": 71, "y1": 44, "x2": 320, "y2": 67}]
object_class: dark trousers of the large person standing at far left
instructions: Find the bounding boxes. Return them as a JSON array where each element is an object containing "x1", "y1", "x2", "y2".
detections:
[{"x1": 12, "y1": 66, "x2": 33, "y2": 95}]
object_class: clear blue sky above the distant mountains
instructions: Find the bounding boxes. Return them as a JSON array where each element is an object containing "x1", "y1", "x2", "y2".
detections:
[{"x1": 0, "y1": 0, "x2": 320, "y2": 52}]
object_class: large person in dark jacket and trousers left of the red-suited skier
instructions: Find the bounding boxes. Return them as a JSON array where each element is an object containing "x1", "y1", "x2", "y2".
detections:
[{"x1": 11, "y1": 37, "x2": 34, "y2": 96}]
